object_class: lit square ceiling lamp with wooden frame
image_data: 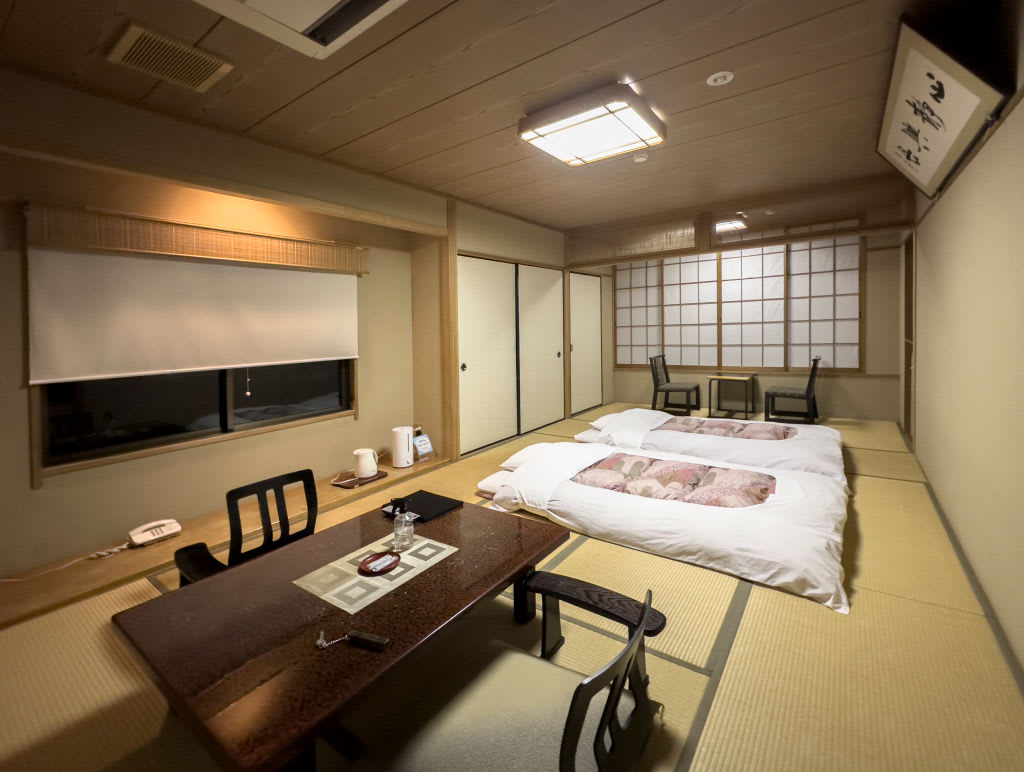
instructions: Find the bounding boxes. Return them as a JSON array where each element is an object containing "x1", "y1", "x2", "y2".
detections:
[{"x1": 519, "y1": 83, "x2": 666, "y2": 166}]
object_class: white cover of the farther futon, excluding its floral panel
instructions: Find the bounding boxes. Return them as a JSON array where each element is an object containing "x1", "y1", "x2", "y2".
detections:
[{"x1": 574, "y1": 408, "x2": 846, "y2": 484}]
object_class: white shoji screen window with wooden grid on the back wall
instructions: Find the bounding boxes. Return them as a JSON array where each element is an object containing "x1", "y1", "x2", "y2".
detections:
[{"x1": 615, "y1": 222, "x2": 861, "y2": 370}]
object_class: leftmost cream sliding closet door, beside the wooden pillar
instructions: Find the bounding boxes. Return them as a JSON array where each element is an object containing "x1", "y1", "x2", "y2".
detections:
[{"x1": 459, "y1": 255, "x2": 518, "y2": 453}]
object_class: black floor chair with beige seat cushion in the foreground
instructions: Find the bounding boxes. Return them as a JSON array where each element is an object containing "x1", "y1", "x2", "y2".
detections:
[{"x1": 346, "y1": 571, "x2": 665, "y2": 772}]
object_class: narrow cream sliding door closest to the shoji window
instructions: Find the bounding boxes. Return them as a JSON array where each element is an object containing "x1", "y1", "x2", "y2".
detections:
[{"x1": 569, "y1": 273, "x2": 602, "y2": 413}]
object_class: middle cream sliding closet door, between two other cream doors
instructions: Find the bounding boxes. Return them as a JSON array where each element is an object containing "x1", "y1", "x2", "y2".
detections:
[{"x1": 519, "y1": 265, "x2": 565, "y2": 433}]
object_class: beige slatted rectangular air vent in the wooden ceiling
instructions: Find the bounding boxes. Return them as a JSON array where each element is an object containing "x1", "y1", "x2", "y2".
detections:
[{"x1": 106, "y1": 25, "x2": 232, "y2": 93}]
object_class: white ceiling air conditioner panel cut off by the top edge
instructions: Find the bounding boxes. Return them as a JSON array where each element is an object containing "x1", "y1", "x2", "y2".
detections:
[{"x1": 196, "y1": 0, "x2": 409, "y2": 59}]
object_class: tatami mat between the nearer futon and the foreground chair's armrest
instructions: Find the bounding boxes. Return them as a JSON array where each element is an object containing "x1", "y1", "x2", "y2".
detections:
[{"x1": 536, "y1": 539, "x2": 736, "y2": 668}]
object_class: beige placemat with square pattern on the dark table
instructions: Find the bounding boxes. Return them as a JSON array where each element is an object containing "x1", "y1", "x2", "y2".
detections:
[{"x1": 292, "y1": 534, "x2": 459, "y2": 614}]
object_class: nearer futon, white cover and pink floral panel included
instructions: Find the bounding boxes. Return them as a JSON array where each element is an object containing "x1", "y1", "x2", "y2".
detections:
[{"x1": 479, "y1": 442, "x2": 849, "y2": 613}]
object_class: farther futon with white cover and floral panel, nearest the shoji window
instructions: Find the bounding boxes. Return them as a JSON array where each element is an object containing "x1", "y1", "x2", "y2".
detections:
[{"x1": 575, "y1": 408, "x2": 846, "y2": 483}]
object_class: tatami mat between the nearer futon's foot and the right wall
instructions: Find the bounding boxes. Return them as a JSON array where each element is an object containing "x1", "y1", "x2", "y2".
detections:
[{"x1": 843, "y1": 476, "x2": 982, "y2": 613}]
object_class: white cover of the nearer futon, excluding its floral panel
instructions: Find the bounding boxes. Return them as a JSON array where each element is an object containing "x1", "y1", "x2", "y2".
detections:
[{"x1": 479, "y1": 442, "x2": 849, "y2": 613}]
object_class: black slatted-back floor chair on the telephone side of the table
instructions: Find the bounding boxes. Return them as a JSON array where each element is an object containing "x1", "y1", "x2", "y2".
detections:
[{"x1": 174, "y1": 469, "x2": 317, "y2": 587}]
